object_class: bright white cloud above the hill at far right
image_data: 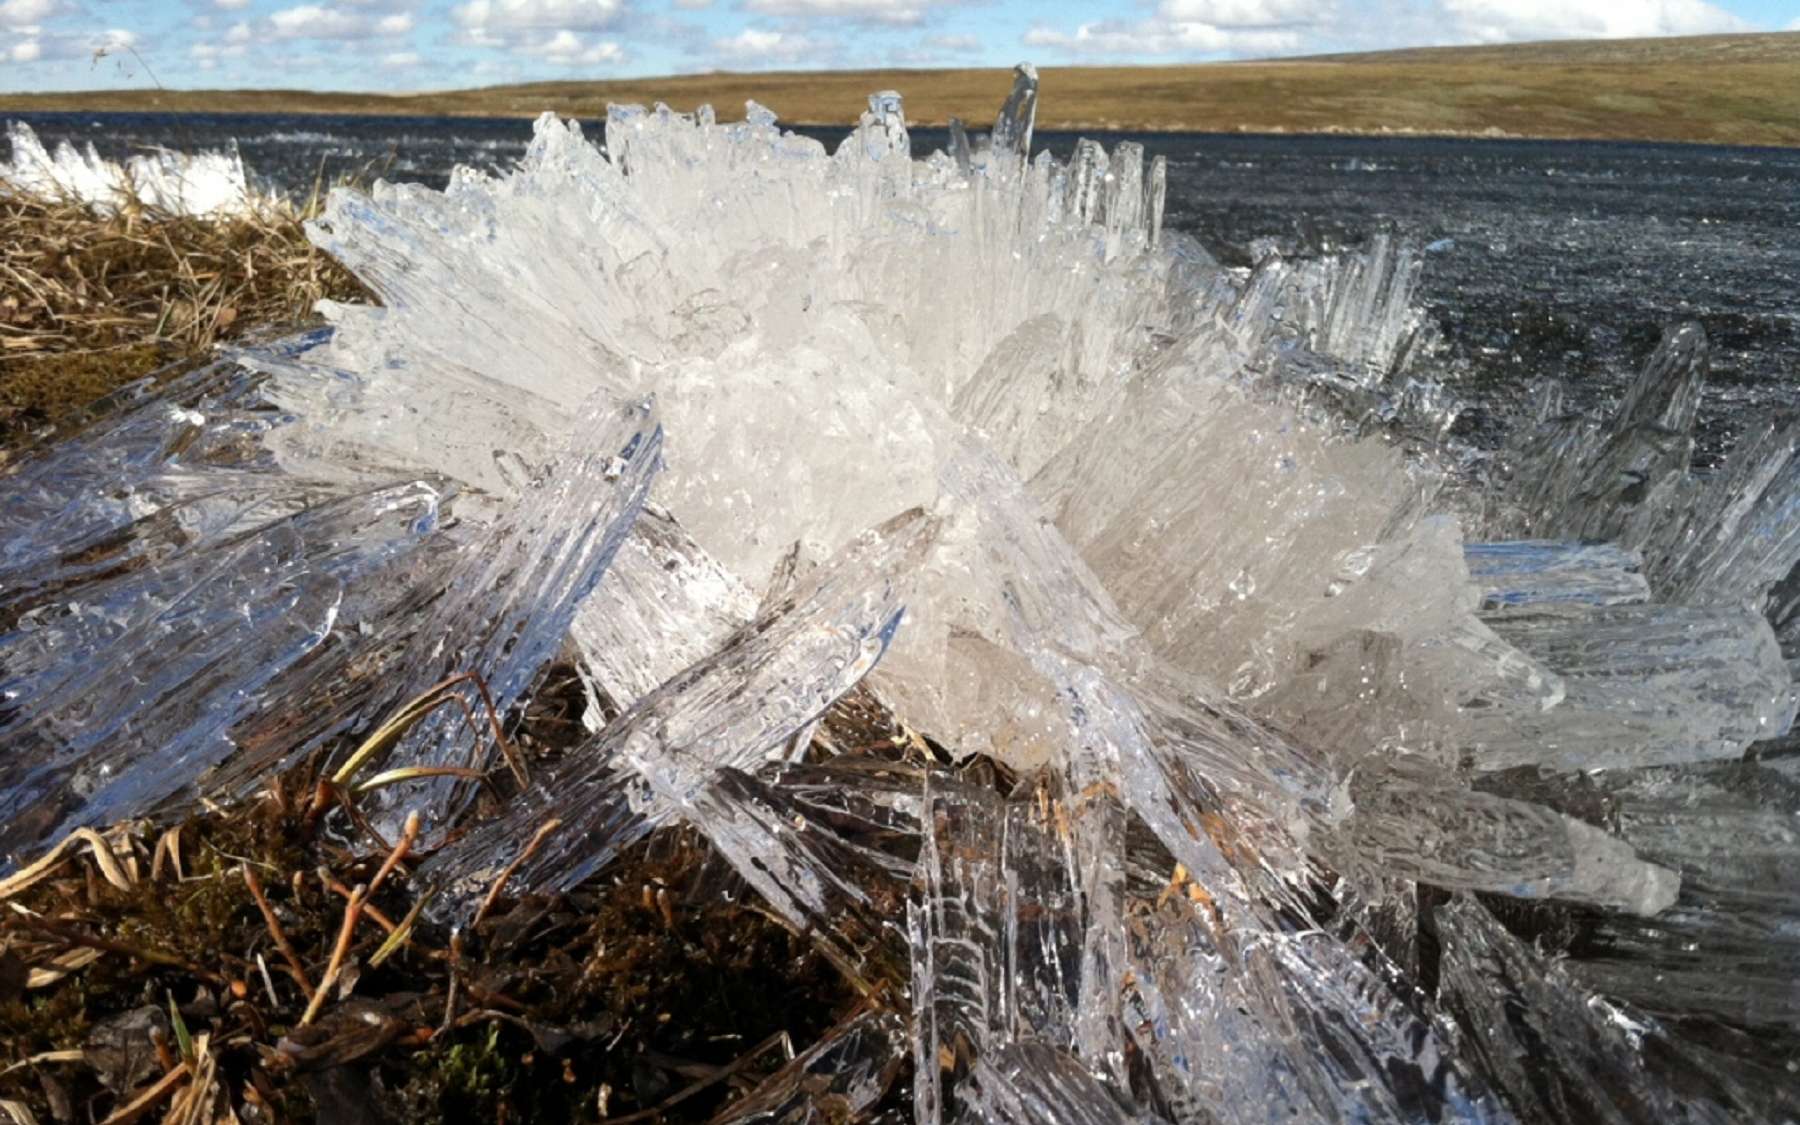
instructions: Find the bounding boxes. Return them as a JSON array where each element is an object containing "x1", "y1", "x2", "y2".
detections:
[{"x1": 1444, "y1": 0, "x2": 1750, "y2": 43}]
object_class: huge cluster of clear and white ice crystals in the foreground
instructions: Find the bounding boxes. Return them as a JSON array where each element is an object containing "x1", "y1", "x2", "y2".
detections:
[{"x1": 0, "y1": 68, "x2": 1800, "y2": 1125}]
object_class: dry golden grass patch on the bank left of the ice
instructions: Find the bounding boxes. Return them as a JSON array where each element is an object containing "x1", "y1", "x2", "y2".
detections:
[{"x1": 0, "y1": 184, "x2": 362, "y2": 441}]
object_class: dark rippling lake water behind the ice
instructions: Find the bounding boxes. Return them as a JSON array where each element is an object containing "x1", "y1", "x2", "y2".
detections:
[{"x1": 14, "y1": 113, "x2": 1800, "y2": 459}]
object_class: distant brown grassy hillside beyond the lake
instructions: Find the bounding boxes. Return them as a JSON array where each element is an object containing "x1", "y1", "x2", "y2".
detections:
[{"x1": 0, "y1": 32, "x2": 1800, "y2": 146}]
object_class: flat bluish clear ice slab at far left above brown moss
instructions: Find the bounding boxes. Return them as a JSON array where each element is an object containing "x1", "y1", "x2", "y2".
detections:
[{"x1": 0, "y1": 488, "x2": 436, "y2": 851}]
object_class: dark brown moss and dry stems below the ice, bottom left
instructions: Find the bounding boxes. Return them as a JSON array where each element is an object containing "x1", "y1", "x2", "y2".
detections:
[{"x1": 0, "y1": 666, "x2": 909, "y2": 1125}]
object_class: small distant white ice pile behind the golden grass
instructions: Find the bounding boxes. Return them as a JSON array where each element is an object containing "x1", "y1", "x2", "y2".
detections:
[{"x1": 0, "y1": 121, "x2": 270, "y2": 218}]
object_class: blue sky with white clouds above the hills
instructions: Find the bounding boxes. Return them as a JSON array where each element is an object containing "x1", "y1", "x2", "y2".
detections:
[{"x1": 0, "y1": 0, "x2": 1800, "y2": 90}]
